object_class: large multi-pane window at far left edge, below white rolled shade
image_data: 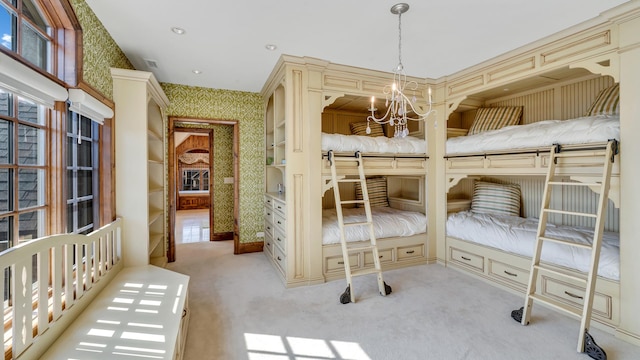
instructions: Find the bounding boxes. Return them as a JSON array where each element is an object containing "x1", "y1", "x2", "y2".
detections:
[{"x1": 0, "y1": 90, "x2": 47, "y2": 251}]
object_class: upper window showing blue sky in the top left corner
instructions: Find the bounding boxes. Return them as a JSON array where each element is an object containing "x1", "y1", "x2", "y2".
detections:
[{"x1": 0, "y1": 0, "x2": 53, "y2": 73}]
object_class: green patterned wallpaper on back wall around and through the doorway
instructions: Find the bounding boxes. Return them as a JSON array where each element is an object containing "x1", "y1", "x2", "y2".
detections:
[{"x1": 161, "y1": 83, "x2": 264, "y2": 243}]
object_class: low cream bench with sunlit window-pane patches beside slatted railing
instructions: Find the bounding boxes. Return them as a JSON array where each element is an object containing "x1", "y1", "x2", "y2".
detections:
[{"x1": 40, "y1": 265, "x2": 190, "y2": 360}]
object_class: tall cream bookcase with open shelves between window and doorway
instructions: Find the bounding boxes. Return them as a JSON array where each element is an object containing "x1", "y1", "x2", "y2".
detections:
[{"x1": 111, "y1": 68, "x2": 169, "y2": 267}]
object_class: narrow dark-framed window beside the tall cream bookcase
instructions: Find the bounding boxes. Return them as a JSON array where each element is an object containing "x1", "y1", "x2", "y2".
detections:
[{"x1": 66, "y1": 111, "x2": 100, "y2": 234}]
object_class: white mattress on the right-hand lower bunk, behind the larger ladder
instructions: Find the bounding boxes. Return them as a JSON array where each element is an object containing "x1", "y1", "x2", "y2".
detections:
[{"x1": 447, "y1": 211, "x2": 620, "y2": 280}]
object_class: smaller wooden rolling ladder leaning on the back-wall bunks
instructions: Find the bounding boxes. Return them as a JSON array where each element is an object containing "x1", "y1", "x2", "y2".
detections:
[{"x1": 327, "y1": 151, "x2": 391, "y2": 304}]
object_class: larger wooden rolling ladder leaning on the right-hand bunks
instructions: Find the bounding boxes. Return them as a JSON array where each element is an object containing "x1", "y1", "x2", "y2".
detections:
[{"x1": 511, "y1": 140, "x2": 618, "y2": 360}]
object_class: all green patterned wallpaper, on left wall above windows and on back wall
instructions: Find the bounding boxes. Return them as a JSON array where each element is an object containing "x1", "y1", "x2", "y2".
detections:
[{"x1": 70, "y1": 0, "x2": 264, "y2": 243}]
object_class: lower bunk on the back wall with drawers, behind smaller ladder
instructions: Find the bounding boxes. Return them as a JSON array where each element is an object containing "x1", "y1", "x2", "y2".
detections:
[{"x1": 322, "y1": 176, "x2": 428, "y2": 281}]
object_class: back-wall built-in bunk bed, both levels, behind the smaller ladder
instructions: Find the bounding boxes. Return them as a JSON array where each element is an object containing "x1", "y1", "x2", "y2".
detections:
[{"x1": 321, "y1": 104, "x2": 428, "y2": 280}]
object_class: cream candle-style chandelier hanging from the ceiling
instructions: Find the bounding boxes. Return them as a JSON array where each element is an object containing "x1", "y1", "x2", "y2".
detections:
[{"x1": 366, "y1": 3, "x2": 435, "y2": 138}]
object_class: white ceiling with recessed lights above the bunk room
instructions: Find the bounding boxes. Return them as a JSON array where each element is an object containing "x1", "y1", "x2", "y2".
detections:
[{"x1": 86, "y1": 0, "x2": 626, "y2": 92}]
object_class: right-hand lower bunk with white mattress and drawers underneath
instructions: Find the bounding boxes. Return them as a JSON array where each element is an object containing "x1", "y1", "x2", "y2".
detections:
[{"x1": 446, "y1": 211, "x2": 620, "y2": 332}]
